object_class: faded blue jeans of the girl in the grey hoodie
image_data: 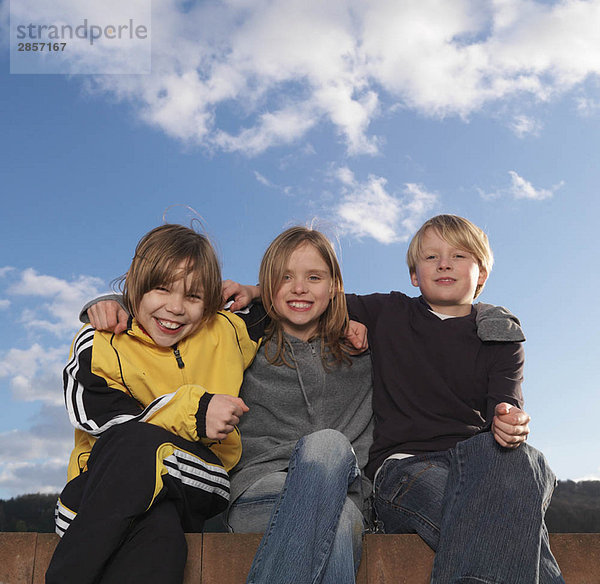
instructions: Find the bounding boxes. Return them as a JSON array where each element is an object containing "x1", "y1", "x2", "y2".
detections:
[{"x1": 228, "y1": 430, "x2": 363, "y2": 584}]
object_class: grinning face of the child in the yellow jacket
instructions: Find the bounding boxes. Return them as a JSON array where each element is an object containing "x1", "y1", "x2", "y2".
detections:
[{"x1": 135, "y1": 262, "x2": 204, "y2": 347}]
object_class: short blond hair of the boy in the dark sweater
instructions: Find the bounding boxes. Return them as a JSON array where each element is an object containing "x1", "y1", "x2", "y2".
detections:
[{"x1": 406, "y1": 215, "x2": 494, "y2": 299}]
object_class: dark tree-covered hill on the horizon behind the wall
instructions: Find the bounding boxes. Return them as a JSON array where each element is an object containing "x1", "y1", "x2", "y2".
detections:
[{"x1": 0, "y1": 481, "x2": 600, "y2": 533}]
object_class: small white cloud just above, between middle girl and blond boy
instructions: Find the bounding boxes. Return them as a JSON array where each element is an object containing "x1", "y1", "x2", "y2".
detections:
[{"x1": 333, "y1": 167, "x2": 438, "y2": 244}]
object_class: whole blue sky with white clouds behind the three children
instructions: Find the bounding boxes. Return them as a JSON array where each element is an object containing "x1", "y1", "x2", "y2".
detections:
[{"x1": 0, "y1": 0, "x2": 600, "y2": 497}]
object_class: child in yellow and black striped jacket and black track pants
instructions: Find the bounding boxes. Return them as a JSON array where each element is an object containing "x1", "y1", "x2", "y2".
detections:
[{"x1": 46, "y1": 225, "x2": 257, "y2": 584}]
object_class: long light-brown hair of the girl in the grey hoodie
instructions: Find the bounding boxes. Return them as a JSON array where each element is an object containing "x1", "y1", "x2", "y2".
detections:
[{"x1": 258, "y1": 226, "x2": 349, "y2": 367}]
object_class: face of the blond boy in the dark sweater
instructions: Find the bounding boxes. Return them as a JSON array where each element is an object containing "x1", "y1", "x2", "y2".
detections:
[{"x1": 410, "y1": 227, "x2": 487, "y2": 316}]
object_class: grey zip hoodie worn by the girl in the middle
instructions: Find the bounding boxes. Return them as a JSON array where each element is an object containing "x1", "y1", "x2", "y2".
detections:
[{"x1": 231, "y1": 335, "x2": 373, "y2": 509}]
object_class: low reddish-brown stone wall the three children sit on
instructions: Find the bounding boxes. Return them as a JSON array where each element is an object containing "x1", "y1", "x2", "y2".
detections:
[{"x1": 0, "y1": 533, "x2": 600, "y2": 584}]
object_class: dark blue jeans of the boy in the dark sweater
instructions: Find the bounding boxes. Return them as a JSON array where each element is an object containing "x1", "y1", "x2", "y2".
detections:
[{"x1": 375, "y1": 432, "x2": 564, "y2": 584}]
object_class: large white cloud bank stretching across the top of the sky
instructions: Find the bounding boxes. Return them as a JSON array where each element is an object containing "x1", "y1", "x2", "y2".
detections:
[{"x1": 11, "y1": 0, "x2": 600, "y2": 155}]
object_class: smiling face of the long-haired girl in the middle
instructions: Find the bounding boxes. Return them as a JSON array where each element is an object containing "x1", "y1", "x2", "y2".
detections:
[{"x1": 273, "y1": 243, "x2": 333, "y2": 341}]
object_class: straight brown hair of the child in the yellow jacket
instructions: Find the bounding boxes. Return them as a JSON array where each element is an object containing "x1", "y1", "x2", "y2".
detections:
[{"x1": 118, "y1": 224, "x2": 223, "y2": 325}]
